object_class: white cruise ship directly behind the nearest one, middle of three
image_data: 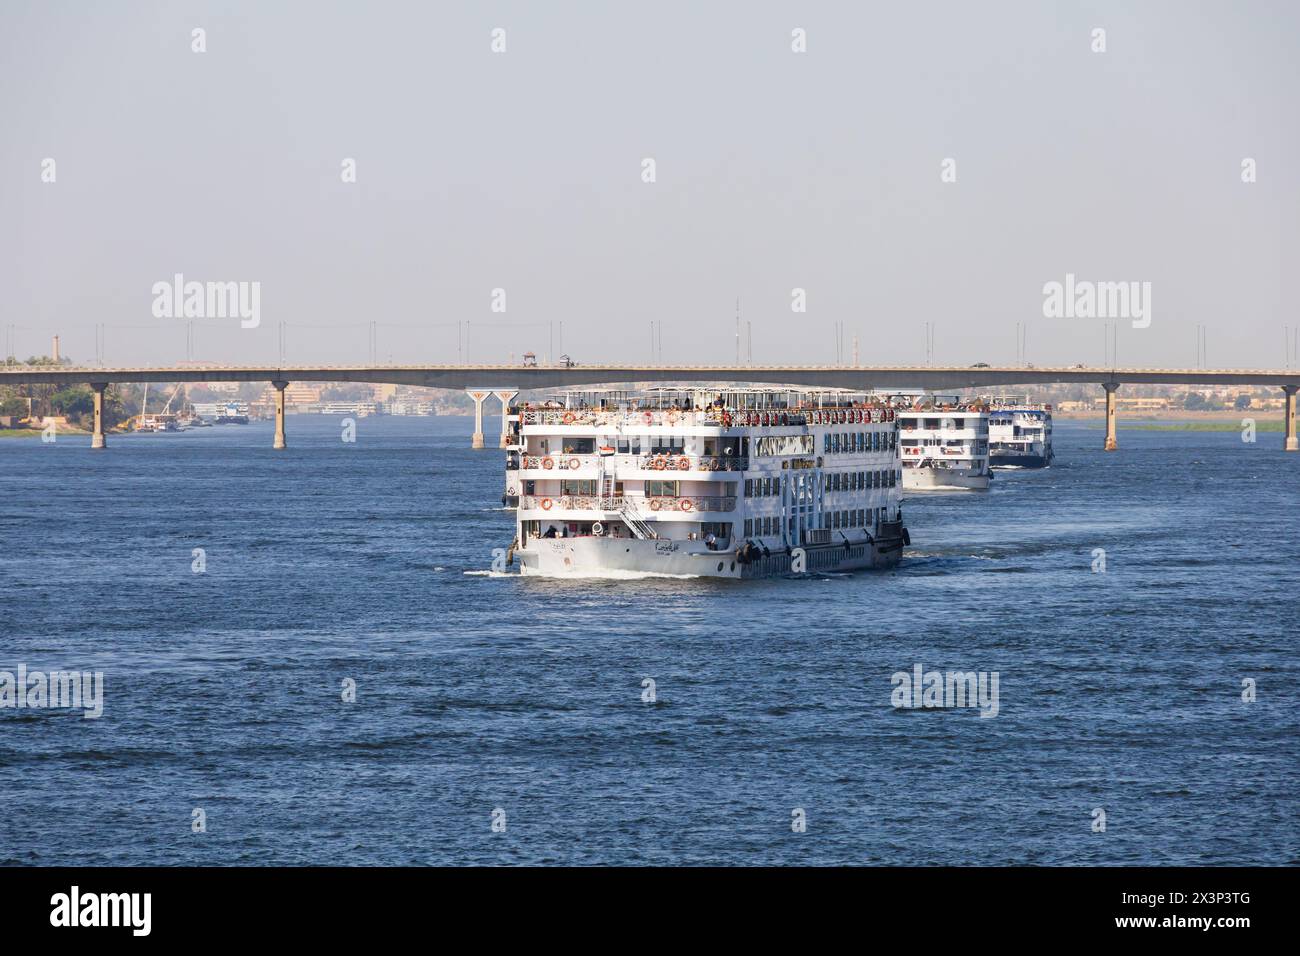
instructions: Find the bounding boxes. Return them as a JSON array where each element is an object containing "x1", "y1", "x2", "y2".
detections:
[{"x1": 898, "y1": 405, "x2": 992, "y2": 492}]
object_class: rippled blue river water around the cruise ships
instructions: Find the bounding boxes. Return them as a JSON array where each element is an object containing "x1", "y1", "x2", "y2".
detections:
[{"x1": 0, "y1": 416, "x2": 1300, "y2": 865}]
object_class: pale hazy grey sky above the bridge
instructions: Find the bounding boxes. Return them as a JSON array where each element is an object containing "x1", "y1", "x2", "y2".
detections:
[{"x1": 0, "y1": 0, "x2": 1300, "y2": 367}]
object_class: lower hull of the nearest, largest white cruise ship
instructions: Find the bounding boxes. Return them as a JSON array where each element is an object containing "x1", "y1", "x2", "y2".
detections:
[{"x1": 514, "y1": 522, "x2": 907, "y2": 580}]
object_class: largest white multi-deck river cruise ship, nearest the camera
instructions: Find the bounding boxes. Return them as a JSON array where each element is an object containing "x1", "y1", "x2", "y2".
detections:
[{"x1": 506, "y1": 389, "x2": 909, "y2": 579}]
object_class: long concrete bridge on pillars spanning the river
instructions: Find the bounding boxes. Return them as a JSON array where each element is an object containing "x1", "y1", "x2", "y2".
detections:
[{"x1": 0, "y1": 364, "x2": 1300, "y2": 451}]
